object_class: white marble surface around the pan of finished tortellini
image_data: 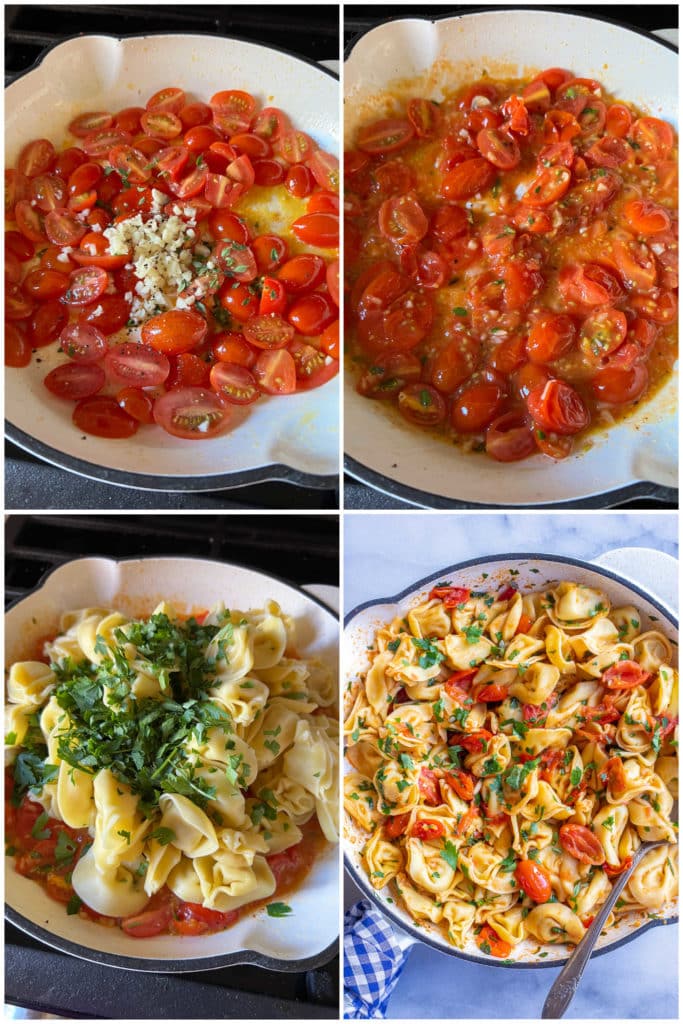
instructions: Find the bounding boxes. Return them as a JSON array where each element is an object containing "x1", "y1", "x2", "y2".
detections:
[{"x1": 344, "y1": 512, "x2": 678, "y2": 1020}]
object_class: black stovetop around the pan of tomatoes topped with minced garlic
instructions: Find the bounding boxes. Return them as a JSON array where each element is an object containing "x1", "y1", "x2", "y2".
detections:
[{"x1": 5, "y1": 4, "x2": 339, "y2": 510}]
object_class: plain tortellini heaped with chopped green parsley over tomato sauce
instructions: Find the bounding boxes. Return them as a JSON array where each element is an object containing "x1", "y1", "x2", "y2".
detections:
[{"x1": 6, "y1": 601, "x2": 339, "y2": 937}]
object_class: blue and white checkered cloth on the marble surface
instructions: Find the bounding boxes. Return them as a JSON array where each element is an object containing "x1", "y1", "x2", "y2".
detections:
[{"x1": 344, "y1": 900, "x2": 410, "y2": 1020}]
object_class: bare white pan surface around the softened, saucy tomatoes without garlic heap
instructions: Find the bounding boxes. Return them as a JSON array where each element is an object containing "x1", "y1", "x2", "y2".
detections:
[{"x1": 344, "y1": 8, "x2": 678, "y2": 506}]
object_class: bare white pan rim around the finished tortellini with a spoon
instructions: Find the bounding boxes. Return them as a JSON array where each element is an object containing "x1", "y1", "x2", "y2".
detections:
[{"x1": 342, "y1": 556, "x2": 678, "y2": 967}]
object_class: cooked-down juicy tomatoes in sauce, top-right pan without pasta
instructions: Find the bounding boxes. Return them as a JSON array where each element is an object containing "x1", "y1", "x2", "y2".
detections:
[{"x1": 344, "y1": 69, "x2": 678, "y2": 462}]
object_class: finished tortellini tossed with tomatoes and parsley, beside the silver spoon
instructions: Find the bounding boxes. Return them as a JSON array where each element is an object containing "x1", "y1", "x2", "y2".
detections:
[{"x1": 343, "y1": 581, "x2": 678, "y2": 957}]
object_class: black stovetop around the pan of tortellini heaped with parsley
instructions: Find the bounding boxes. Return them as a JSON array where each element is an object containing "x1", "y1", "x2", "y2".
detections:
[{"x1": 5, "y1": 514, "x2": 339, "y2": 1020}]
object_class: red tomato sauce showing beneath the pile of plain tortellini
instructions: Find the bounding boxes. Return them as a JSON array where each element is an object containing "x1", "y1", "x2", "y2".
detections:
[{"x1": 5, "y1": 768, "x2": 327, "y2": 938}]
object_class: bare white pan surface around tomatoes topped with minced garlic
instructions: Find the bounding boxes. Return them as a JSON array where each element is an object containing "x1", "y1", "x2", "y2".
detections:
[{"x1": 5, "y1": 35, "x2": 339, "y2": 490}]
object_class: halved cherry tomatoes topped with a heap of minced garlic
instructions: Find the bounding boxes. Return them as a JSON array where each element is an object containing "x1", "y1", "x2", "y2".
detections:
[{"x1": 5, "y1": 87, "x2": 339, "y2": 439}]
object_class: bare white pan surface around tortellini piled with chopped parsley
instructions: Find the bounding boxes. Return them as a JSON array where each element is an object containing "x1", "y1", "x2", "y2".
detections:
[{"x1": 5, "y1": 558, "x2": 339, "y2": 971}]
